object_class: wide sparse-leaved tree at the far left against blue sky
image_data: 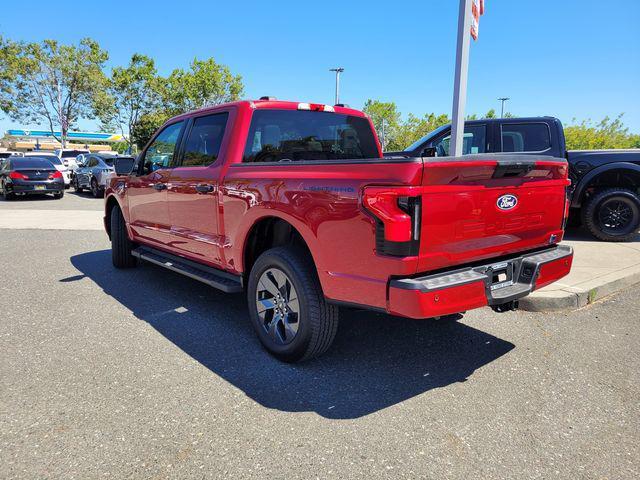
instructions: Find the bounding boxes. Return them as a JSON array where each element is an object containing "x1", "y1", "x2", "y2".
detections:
[{"x1": 0, "y1": 38, "x2": 108, "y2": 148}]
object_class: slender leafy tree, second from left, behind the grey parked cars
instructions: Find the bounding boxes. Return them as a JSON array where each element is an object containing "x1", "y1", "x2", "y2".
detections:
[{"x1": 94, "y1": 53, "x2": 161, "y2": 150}]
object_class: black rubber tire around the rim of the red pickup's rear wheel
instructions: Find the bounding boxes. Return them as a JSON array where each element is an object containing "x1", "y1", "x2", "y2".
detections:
[{"x1": 247, "y1": 247, "x2": 338, "y2": 362}]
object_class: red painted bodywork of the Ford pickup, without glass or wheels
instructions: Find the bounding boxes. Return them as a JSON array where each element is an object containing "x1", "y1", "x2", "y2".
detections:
[{"x1": 106, "y1": 101, "x2": 570, "y2": 318}]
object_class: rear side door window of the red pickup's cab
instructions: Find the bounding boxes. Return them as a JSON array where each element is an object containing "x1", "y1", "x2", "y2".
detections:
[{"x1": 182, "y1": 112, "x2": 229, "y2": 167}]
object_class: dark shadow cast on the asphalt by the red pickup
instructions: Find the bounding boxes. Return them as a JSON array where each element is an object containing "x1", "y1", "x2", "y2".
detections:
[{"x1": 67, "y1": 250, "x2": 514, "y2": 419}]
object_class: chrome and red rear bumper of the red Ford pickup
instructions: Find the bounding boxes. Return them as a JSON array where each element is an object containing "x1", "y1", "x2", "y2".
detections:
[{"x1": 388, "y1": 245, "x2": 573, "y2": 318}]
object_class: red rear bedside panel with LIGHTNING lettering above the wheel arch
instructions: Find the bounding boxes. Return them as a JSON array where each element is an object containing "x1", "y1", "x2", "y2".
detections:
[{"x1": 221, "y1": 159, "x2": 422, "y2": 308}]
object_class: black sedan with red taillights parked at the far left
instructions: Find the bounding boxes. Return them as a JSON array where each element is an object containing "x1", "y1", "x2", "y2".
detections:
[{"x1": 0, "y1": 157, "x2": 64, "y2": 200}]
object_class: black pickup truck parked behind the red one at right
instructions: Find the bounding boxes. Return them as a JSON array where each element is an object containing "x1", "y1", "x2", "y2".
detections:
[{"x1": 384, "y1": 117, "x2": 640, "y2": 242}]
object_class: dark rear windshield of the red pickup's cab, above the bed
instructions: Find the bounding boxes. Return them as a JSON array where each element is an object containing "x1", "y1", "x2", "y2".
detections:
[{"x1": 243, "y1": 110, "x2": 379, "y2": 162}]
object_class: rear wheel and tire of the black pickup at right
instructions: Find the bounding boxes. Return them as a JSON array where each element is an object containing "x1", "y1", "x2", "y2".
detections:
[{"x1": 582, "y1": 188, "x2": 640, "y2": 242}]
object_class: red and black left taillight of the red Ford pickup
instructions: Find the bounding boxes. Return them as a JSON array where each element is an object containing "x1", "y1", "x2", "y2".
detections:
[{"x1": 362, "y1": 187, "x2": 422, "y2": 257}]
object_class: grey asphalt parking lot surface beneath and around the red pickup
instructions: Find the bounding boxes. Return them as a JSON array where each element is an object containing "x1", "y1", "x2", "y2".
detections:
[{"x1": 0, "y1": 192, "x2": 640, "y2": 479}]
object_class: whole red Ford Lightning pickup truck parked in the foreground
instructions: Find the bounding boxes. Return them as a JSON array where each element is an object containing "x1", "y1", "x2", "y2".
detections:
[{"x1": 104, "y1": 98, "x2": 573, "y2": 362}]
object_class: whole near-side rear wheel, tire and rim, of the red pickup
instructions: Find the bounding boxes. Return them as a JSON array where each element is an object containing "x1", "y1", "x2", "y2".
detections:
[{"x1": 247, "y1": 247, "x2": 338, "y2": 362}]
